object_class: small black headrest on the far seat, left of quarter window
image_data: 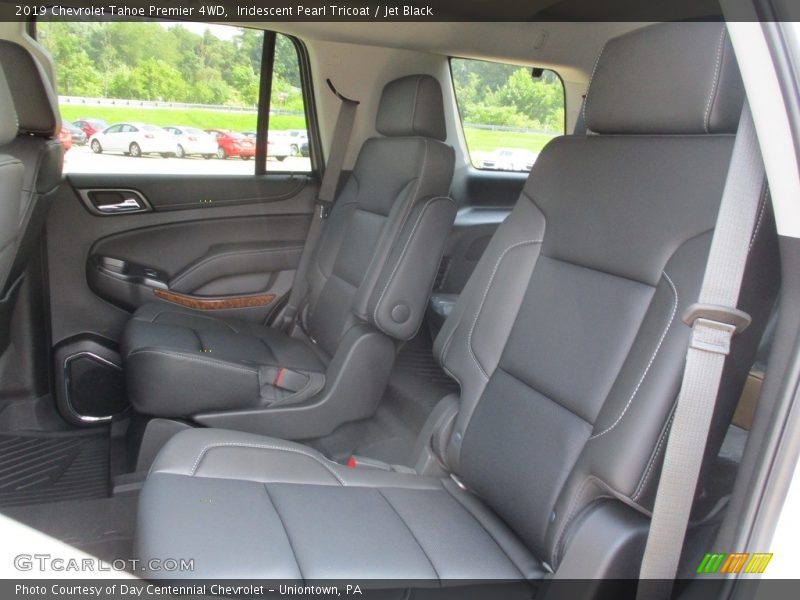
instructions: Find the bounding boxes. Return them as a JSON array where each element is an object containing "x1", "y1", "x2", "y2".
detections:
[{"x1": 375, "y1": 75, "x2": 447, "y2": 140}]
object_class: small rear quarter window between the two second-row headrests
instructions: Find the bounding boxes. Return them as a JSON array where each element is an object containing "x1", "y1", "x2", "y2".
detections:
[{"x1": 450, "y1": 58, "x2": 564, "y2": 171}]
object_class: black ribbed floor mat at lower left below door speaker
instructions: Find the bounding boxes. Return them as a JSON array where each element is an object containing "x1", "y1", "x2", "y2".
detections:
[{"x1": 0, "y1": 429, "x2": 110, "y2": 506}]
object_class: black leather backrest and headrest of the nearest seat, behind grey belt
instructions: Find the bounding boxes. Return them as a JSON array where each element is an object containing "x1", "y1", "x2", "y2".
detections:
[{"x1": 435, "y1": 23, "x2": 778, "y2": 567}]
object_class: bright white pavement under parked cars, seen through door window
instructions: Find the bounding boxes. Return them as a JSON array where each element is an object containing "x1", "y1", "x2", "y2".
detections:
[{"x1": 64, "y1": 146, "x2": 311, "y2": 175}]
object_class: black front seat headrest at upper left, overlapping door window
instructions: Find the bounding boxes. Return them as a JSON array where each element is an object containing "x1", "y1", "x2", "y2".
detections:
[{"x1": 0, "y1": 40, "x2": 61, "y2": 136}]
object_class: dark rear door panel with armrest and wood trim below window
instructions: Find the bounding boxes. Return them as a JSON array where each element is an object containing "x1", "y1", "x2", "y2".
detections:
[{"x1": 47, "y1": 174, "x2": 318, "y2": 345}]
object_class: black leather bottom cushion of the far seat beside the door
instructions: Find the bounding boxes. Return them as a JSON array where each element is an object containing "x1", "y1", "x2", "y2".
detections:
[{"x1": 122, "y1": 304, "x2": 328, "y2": 417}]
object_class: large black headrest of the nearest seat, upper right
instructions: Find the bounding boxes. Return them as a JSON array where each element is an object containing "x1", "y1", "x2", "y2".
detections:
[{"x1": 584, "y1": 23, "x2": 744, "y2": 134}]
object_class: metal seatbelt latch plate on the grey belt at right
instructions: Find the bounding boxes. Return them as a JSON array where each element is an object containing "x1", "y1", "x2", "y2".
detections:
[{"x1": 683, "y1": 302, "x2": 752, "y2": 355}]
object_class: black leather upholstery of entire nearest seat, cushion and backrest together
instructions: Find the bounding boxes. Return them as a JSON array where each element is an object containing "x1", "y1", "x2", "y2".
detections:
[{"x1": 138, "y1": 23, "x2": 778, "y2": 579}]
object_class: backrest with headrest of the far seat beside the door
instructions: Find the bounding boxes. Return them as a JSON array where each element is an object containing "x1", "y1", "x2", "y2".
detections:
[{"x1": 305, "y1": 75, "x2": 455, "y2": 354}]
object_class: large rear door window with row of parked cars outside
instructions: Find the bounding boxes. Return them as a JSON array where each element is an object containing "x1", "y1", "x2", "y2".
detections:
[{"x1": 37, "y1": 20, "x2": 310, "y2": 175}]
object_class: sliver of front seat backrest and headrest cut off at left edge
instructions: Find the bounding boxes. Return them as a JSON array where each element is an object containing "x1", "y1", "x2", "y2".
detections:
[{"x1": 0, "y1": 65, "x2": 25, "y2": 296}]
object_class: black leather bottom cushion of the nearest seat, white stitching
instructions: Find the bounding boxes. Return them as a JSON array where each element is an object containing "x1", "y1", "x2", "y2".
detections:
[{"x1": 136, "y1": 429, "x2": 544, "y2": 584}]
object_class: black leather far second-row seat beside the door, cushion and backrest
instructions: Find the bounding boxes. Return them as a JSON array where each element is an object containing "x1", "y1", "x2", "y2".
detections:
[{"x1": 122, "y1": 75, "x2": 456, "y2": 416}]
